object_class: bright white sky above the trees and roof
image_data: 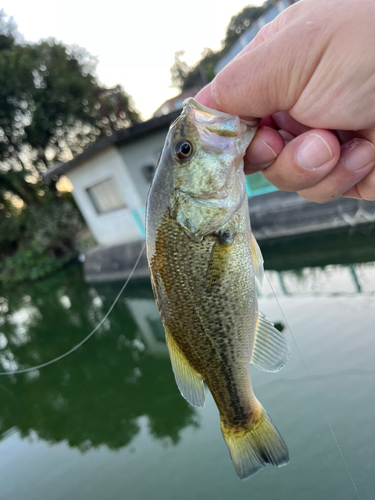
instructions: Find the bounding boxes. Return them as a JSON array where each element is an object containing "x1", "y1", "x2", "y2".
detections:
[{"x1": 1, "y1": 0, "x2": 263, "y2": 119}]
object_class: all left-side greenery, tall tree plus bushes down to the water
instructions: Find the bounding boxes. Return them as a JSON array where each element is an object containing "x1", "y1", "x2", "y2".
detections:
[{"x1": 0, "y1": 11, "x2": 140, "y2": 281}]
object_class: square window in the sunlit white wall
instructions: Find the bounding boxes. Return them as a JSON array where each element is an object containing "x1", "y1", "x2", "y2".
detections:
[{"x1": 86, "y1": 177, "x2": 126, "y2": 214}]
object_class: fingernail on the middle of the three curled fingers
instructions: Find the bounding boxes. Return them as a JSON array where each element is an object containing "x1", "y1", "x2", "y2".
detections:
[{"x1": 296, "y1": 134, "x2": 333, "y2": 170}]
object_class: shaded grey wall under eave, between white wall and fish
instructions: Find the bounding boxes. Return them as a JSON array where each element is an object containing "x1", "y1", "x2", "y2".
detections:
[{"x1": 119, "y1": 127, "x2": 168, "y2": 206}]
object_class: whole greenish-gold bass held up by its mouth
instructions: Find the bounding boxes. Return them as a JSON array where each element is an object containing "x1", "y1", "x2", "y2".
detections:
[{"x1": 146, "y1": 98, "x2": 290, "y2": 479}]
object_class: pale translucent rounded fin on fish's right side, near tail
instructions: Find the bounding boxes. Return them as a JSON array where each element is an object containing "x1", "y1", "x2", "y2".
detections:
[{"x1": 251, "y1": 312, "x2": 290, "y2": 372}]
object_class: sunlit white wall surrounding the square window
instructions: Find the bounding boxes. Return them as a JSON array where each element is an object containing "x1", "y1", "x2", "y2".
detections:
[{"x1": 66, "y1": 146, "x2": 144, "y2": 246}]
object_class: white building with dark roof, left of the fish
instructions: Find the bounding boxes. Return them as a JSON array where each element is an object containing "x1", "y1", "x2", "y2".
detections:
[{"x1": 44, "y1": 110, "x2": 180, "y2": 246}]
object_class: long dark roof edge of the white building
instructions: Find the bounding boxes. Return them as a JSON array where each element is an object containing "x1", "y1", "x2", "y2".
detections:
[{"x1": 43, "y1": 109, "x2": 181, "y2": 182}]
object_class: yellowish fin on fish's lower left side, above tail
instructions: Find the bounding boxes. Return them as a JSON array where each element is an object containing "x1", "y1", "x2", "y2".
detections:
[{"x1": 165, "y1": 331, "x2": 204, "y2": 406}]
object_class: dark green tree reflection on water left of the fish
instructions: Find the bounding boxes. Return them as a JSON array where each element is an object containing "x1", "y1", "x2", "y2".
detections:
[{"x1": 0, "y1": 268, "x2": 198, "y2": 451}]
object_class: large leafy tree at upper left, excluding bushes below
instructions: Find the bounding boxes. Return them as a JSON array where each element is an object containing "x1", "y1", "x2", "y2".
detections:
[{"x1": 0, "y1": 12, "x2": 140, "y2": 207}]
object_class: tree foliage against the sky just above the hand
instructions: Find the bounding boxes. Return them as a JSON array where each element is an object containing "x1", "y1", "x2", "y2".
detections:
[{"x1": 171, "y1": 5, "x2": 264, "y2": 91}]
